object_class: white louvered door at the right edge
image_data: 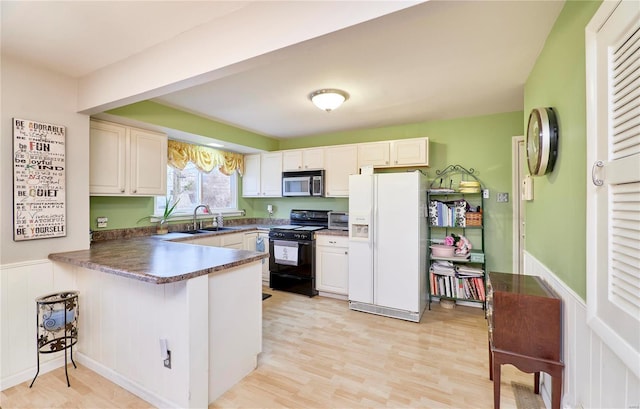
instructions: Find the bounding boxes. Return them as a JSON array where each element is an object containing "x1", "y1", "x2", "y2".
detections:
[{"x1": 587, "y1": 1, "x2": 640, "y2": 373}]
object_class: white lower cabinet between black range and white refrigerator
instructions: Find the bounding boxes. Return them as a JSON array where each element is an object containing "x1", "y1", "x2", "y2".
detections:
[{"x1": 316, "y1": 235, "x2": 349, "y2": 298}]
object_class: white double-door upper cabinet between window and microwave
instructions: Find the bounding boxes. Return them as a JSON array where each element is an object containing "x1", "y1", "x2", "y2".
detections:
[{"x1": 242, "y1": 152, "x2": 282, "y2": 197}]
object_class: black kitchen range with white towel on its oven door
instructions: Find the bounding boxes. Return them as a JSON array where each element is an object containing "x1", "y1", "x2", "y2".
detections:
[{"x1": 269, "y1": 210, "x2": 329, "y2": 297}]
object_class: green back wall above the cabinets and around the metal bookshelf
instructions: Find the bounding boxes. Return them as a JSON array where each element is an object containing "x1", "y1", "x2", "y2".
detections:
[{"x1": 268, "y1": 111, "x2": 523, "y2": 272}]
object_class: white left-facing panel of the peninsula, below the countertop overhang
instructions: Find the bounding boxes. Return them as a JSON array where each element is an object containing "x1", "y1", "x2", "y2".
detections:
[{"x1": 72, "y1": 267, "x2": 191, "y2": 407}]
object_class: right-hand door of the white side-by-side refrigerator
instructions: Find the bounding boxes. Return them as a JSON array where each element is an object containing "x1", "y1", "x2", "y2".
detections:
[{"x1": 373, "y1": 172, "x2": 420, "y2": 312}]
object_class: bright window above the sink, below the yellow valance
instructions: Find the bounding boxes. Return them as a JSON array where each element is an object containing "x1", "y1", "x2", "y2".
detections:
[{"x1": 155, "y1": 163, "x2": 238, "y2": 214}]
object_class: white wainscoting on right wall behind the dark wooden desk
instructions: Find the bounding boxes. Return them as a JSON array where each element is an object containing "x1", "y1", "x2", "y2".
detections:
[{"x1": 524, "y1": 252, "x2": 640, "y2": 409}]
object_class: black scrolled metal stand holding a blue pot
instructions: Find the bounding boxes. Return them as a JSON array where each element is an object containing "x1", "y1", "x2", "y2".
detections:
[{"x1": 29, "y1": 291, "x2": 79, "y2": 388}]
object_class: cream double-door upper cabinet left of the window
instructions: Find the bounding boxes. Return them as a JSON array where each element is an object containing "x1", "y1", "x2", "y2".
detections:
[{"x1": 89, "y1": 120, "x2": 167, "y2": 196}]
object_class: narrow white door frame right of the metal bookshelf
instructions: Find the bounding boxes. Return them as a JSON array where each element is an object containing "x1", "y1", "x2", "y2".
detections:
[{"x1": 511, "y1": 135, "x2": 525, "y2": 274}]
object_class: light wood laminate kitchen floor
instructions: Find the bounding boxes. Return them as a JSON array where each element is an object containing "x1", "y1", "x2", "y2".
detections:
[{"x1": 0, "y1": 290, "x2": 533, "y2": 409}]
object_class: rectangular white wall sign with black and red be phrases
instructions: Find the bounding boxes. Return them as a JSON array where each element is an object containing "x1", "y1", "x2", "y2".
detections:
[{"x1": 13, "y1": 118, "x2": 67, "y2": 241}]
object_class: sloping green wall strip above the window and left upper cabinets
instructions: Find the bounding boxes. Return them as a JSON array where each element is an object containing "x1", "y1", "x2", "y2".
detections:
[{"x1": 107, "y1": 101, "x2": 278, "y2": 151}]
